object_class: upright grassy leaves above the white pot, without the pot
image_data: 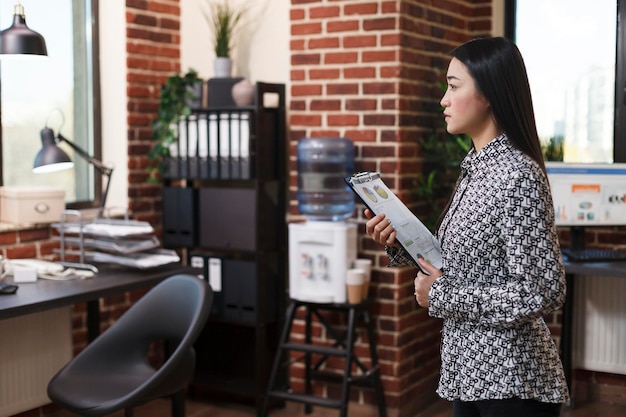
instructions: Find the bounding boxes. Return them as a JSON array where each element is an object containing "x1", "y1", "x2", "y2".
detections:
[{"x1": 205, "y1": 0, "x2": 246, "y2": 58}]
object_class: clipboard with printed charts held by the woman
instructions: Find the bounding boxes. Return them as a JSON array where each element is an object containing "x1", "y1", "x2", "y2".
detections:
[{"x1": 345, "y1": 172, "x2": 442, "y2": 269}]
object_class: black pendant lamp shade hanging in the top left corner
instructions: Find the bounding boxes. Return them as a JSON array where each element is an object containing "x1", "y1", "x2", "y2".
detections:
[{"x1": 0, "y1": 4, "x2": 48, "y2": 56}]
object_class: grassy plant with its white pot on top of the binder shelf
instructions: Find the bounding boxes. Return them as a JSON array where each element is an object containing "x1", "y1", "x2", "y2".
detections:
[{"x1": 205, "y1": 0, "x2": 245, "y2": 78}]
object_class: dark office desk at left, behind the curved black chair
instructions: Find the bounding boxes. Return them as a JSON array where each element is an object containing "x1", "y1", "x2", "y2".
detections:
[{"x1": 0, "y1": 264, "x2": 191, "y2": 341}]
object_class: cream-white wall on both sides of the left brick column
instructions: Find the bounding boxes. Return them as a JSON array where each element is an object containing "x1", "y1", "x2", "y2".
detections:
[{"x1": 99, "y1": 0, "x2": 290, "y2": 208}]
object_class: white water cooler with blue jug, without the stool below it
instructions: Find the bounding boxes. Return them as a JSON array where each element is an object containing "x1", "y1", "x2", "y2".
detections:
[{"x1": 289, "y1": 138, "x2": 357, "y2": 303}]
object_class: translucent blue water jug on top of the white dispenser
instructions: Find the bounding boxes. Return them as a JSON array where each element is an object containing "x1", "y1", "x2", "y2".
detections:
[{"x1": 297, "y1": 137, "x2": 354, "y2": 221}]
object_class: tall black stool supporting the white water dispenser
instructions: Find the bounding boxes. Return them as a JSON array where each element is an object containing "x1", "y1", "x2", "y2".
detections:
[{"x1": 260, "y1": 299, "x2": 387, "y2": 417}]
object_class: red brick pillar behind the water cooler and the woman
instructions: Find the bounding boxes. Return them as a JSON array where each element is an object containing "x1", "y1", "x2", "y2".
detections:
[{"x1": 289, "y1": 0, "x2": 491, "y2": 416}]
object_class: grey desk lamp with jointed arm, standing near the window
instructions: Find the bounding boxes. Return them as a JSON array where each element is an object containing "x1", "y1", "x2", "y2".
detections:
[{"x1": 33, "y1": 126, "x2": 113, "y2": 218}]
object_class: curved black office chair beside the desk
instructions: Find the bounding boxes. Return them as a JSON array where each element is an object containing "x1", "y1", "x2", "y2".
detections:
[{"x1": 48, "y1": 275, "x2": 213, "y2": 417}]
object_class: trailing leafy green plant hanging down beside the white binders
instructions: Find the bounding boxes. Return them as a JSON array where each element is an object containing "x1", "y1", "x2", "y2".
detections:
[{"x1": 148, "y1": 69, "x2": 202, "y2": 181}]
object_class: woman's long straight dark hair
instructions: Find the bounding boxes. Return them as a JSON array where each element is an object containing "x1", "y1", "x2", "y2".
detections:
[{"x1": 437, "y1": 37, "x2": 546, "y2": 229}]
